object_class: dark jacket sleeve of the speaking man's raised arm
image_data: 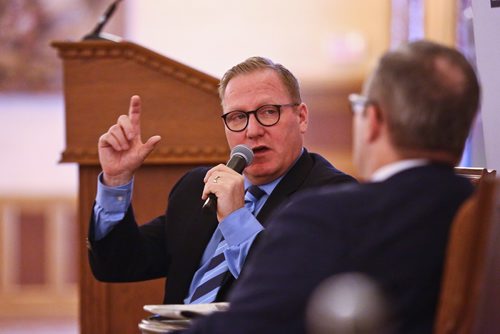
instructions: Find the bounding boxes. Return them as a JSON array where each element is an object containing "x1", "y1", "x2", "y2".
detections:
[{"x1": 88, "y1": 168, "x2": 206, "y2": 282}]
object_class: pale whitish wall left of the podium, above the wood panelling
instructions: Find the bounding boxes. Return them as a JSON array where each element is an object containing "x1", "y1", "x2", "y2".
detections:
[{"x1": 0, "y1": 93, "x2": 77, "y2": 196}]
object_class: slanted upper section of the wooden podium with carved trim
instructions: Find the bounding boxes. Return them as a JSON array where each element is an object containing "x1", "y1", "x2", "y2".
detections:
[{"x1": 53, "y1": 41, "x2": 229, "y2": 164}]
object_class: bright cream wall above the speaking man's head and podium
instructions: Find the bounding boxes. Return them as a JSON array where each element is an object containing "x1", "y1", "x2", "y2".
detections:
[{"x1": 124, "y1": 0, "x2": 390, "y2": 82}]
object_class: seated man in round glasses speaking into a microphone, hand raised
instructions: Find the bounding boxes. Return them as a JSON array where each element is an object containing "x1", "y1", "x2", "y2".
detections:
[{"x1": 88, "y1": 57, "x2": 354, "y2": 303}]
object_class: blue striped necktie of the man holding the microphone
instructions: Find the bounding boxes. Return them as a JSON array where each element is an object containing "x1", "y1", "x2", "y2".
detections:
[{"x1": 190, "y1": 186, "x2": 265, "y2": 304}]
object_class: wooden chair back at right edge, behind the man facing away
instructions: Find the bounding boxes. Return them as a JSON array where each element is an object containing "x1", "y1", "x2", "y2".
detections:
[{"x1": 434, "y1": 174, "x2": 500, "y2": 334}]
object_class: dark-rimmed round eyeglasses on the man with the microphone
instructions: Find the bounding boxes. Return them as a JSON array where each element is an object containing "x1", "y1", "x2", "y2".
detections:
[{"x1": 221, "y1": 103, "x2": 300, "y2": 132}]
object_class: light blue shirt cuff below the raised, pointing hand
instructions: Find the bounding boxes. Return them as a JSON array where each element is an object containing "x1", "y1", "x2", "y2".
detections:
[{"x1": 96, "y1": 172, "x2": 134, "y2": 212}]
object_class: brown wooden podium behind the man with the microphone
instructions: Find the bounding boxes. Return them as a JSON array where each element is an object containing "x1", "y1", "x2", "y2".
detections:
[{"x1": 52, "y1": 41, "x2": 229, "y2": 334}]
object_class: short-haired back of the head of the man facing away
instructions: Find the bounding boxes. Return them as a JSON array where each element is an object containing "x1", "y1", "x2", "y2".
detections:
[{"x1": 365, "y1": 41, "x2": 480, "y2": 161}]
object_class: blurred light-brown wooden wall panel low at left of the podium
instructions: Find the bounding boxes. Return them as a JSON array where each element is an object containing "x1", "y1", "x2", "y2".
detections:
[{"x1": 0, "y1": 197, "x2": 78, "y2": 318}]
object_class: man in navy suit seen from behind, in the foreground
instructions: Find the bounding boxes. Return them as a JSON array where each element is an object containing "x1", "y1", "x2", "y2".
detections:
[{"x1": 178, "y1": 41, "x2": 479, "y2": 334}]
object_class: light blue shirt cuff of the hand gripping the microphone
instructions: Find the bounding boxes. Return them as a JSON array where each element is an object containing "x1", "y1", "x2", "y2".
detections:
[{"x1": 219, "y1": 207, "x2": 264, "y2": 247}]
